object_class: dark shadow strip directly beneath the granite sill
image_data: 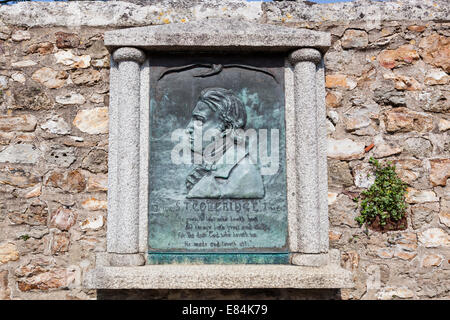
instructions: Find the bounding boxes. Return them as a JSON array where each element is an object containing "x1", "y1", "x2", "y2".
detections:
[{"x1": 97, "y1": 289, "x2": 341, "y2": 300}]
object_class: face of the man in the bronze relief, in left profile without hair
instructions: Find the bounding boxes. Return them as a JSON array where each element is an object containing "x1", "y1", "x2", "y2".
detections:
[{"x1": 186, "y1": 101, "x2": 224, "y2": 153}]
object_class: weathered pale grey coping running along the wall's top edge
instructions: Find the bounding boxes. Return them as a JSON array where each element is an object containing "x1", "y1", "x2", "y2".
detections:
[{"x1": 0, "y1": 0, "x2": 448, "y2": 27}]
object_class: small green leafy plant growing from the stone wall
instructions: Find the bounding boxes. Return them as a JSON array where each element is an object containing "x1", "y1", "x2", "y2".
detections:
[{"x1": 354, "y1": 158, "x2": 407, "y2": 226}]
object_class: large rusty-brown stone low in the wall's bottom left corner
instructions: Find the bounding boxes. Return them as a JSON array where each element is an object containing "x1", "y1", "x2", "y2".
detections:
[{"x1": 15, "y1": 259, "x2": 75, "y2": 291}]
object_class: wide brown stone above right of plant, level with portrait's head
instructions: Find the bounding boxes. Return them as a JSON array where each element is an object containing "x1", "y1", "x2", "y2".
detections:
[{"x1": 385, "y1": 108, "x2": 433, "y2": 132}]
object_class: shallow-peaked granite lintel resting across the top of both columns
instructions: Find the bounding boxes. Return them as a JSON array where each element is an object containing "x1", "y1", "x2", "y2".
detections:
[{"x1": 105, "y1": 19, "x2": 331, "y2": 53}]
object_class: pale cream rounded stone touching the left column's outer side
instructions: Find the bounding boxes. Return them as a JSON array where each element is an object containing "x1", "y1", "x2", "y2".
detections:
[{"x1": 73, "y1": 107, "x2": 109, "y2": 134}]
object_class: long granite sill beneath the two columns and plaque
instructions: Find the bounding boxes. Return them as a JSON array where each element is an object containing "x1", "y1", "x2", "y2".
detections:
[{"x1": 84, "y1": 264, "x2": 354, "y2": 289}]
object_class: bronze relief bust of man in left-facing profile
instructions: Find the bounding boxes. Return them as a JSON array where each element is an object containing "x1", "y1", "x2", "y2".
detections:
[{"x1": 186, "y1": 88, "x2": 264, "y2": 199}]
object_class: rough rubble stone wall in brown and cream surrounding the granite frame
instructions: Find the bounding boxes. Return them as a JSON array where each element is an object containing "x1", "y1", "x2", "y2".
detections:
[{"x1": 0, "y1": 0, "x2": 450, "y2": 299}]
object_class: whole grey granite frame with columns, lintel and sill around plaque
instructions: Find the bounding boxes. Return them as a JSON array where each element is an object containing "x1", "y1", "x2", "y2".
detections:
[{"x1": 85, "y1": 19, "x2": 353, "y2": 289}]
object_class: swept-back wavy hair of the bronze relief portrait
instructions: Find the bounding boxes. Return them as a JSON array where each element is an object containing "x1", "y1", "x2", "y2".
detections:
[{"x1": 199, "y1": 88, "x2": 247, "y2": 129}]
